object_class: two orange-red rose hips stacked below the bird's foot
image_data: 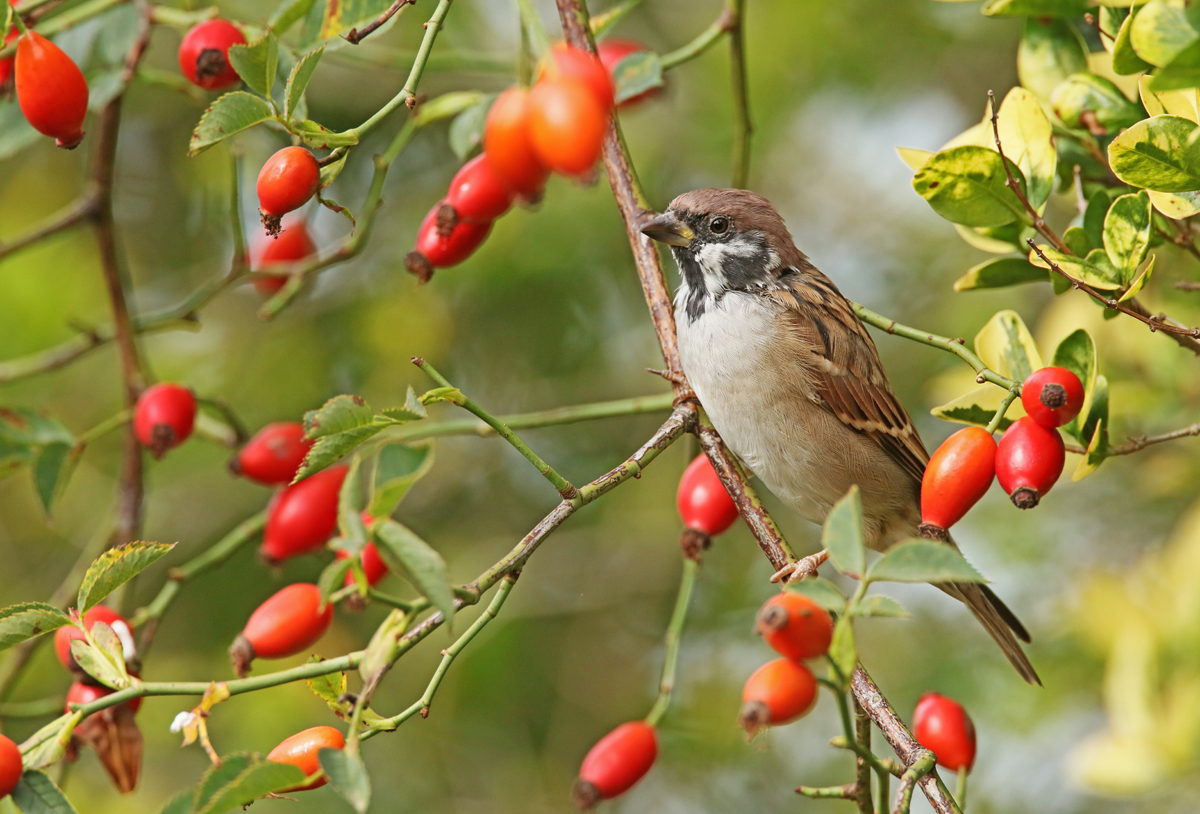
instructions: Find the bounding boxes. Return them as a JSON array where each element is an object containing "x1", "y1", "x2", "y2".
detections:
[{"x1": 738, "y1": 592, "x2": 833, "y2": 737}]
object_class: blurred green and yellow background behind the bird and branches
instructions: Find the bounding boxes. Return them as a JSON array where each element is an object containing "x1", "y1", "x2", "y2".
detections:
[{"x1": 0, "y1": 0, "x2": 1200, "y2": 814}]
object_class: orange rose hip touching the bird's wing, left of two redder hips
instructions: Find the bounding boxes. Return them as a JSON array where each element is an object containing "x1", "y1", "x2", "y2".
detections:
[{"x1": 920, "y1": 426, "x2": 996, "y2": 537}]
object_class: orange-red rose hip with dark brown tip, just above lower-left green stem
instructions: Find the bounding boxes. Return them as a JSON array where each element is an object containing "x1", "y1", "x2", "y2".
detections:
[{"x1": 229, "y1": 582, "x2": 334, "y2": 677}]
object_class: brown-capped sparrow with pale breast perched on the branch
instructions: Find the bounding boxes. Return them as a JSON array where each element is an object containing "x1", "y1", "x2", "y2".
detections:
[{"x1": 641, "y1": 188, "x2": 1042, "y2": 686}]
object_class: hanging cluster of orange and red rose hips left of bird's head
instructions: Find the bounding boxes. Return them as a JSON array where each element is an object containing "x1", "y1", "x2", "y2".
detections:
[{"x1": 404, "y1": 43, "x2": 613, "y2": 282}]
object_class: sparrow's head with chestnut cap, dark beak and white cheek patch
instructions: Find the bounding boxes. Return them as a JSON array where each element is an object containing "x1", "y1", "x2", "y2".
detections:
[{"x1": 642, "y1": 190, "x2": 805, "y2": 312}]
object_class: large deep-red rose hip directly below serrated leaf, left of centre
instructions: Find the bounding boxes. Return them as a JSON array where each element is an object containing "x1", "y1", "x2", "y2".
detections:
[{"x1": 258, "y1": 465, "x2": 349, "y2": 565}]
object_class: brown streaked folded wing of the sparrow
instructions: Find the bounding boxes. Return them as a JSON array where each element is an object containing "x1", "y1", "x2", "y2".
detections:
[{"x1": 770, "y1": 263, "x2": 929, "y2": 481}]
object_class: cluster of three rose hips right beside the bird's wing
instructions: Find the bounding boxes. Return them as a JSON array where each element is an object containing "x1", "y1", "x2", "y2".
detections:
[{"x1": 920, "y1": 367, "x2": 1084, "y2": 537}]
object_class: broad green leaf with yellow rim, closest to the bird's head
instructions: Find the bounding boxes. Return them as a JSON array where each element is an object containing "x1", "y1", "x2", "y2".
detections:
[{"x1": 912, "y1": 145, "x2": 1026, "y2": 226}]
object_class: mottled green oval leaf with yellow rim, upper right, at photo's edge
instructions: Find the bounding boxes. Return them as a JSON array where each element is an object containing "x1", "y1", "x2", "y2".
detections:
[{"x1": 1109, "y1": 114, "x2": 1200, "y2": 192}]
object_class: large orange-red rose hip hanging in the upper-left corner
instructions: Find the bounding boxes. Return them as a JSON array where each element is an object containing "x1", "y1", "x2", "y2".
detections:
[{"x1": 14, "y1": 31, "x2": 88, "y2": 150}]
